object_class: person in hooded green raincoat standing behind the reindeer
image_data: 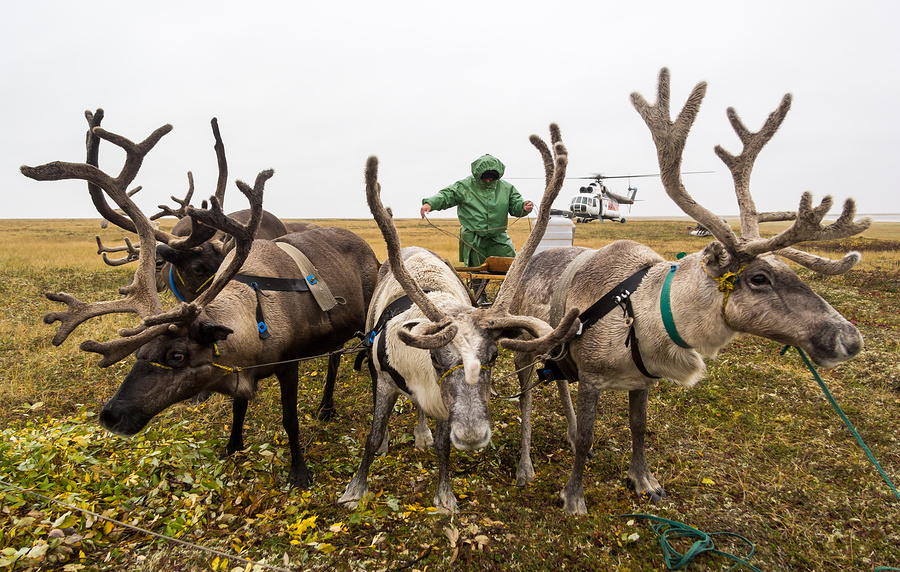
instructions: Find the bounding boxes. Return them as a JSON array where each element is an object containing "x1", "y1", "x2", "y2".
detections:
[{"x1": 420, "y1": 155, "x2": 534, "y2": 266}]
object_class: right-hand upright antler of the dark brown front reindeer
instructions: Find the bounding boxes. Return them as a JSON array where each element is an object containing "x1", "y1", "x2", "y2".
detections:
[{"x1": 188, "y1": 169, "x2": 275, "y2": 308}]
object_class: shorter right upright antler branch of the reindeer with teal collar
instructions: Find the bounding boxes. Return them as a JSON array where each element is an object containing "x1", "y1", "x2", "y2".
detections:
[{"x1": 715, "y1": 93, "x2": 792, "y2": 240}]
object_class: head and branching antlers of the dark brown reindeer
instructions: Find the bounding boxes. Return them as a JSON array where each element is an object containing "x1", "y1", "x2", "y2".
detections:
[{"x1": 21, "y1": 112, "x2": 273, "y2": 434}]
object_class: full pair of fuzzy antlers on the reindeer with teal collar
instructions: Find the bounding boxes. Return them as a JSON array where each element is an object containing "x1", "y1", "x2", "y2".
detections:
[{"x1": 631, "y1": 68, "x2": 871, "y2": 274}]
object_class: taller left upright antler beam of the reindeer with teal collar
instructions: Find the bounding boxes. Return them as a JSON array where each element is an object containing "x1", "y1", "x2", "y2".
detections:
[{"x1": 631, "y1": 68, "x2": 738, "y2": 249}]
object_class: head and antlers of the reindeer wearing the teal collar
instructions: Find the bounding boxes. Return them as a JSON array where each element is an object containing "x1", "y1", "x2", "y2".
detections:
[{"x1": 631, "y1": 68, "x2": 871, "y2": 366}]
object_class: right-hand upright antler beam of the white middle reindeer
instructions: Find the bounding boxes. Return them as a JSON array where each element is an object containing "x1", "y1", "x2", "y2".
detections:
[{"x1": 491, "y1": 123, "x2": 569, "y2": 312}]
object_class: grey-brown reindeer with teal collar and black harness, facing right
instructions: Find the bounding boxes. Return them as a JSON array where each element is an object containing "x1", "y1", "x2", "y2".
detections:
[{"x1": 511, "y1": 69, "x2": 870, "y2": 514}]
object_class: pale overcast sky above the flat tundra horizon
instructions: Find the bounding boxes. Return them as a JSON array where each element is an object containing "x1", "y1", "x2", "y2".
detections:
[{"x1": 0, "y1": 0, "x2": 900, "y2": 218}]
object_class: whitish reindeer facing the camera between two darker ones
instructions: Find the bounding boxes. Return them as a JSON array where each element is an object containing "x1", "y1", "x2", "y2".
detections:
[{"x1": 338, "y1": 125, "x2": 578, "y2": 512}]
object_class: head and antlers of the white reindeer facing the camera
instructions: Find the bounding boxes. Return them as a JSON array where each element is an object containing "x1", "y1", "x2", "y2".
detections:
[{"x1": 366, "y1": 125, "x2": 579, "y2": 449}]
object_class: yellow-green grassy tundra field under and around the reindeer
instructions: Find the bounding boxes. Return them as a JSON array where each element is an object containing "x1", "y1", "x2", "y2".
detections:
[{"x1": 0, "y1": 219, "x2": 900, "y2": 572}]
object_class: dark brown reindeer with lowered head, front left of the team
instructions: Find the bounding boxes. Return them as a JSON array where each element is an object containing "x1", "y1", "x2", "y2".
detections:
[{"x1": 21, "y1": 116, "x2": 378, "y2": 487}]
